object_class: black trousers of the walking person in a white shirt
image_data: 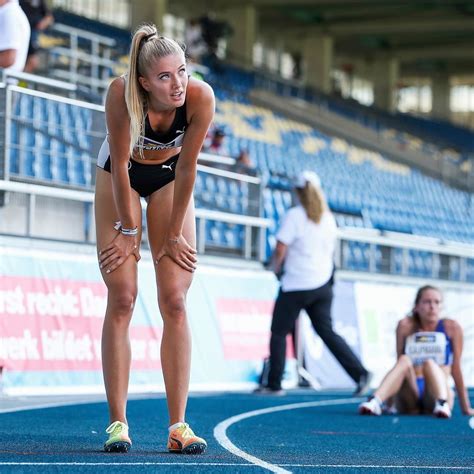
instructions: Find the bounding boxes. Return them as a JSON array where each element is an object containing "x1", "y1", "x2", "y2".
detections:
[{"x1": 268, "y1": 278, "x2": 367, "y2": 389}]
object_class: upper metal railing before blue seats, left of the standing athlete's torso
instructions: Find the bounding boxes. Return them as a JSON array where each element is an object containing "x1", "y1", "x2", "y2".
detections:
[{"x1": 0, "y1": 81, "x2": 105, "y2": 184}]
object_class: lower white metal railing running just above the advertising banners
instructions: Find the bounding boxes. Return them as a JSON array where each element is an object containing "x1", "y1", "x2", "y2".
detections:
[{"x1": 0, "y1": 180, "x2": 474, "y2": 283}]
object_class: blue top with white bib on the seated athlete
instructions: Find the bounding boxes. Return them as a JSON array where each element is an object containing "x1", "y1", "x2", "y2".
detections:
[{"x1": 404, "y1": 319, "x2": 453, "y2": 366}]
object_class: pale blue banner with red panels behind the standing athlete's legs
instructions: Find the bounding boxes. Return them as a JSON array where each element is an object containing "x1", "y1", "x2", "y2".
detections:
[{"x1": 0, "y1": 248, "x2": 277, "y2": 394}]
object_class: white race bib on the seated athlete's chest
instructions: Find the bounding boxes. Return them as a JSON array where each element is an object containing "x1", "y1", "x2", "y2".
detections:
[{"x1": 405, "y1": 332, "x2": 447, "y2": 365}]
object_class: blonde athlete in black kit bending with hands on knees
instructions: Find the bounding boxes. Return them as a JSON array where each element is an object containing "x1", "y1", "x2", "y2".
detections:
[{"x1": 95, "y1": 25, "x2": 214, "y2": 454}]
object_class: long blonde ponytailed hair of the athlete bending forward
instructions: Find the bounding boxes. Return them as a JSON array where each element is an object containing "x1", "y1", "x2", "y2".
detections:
[{"x1": 125, "y1": 24, "x2": 184, "y2": 157}]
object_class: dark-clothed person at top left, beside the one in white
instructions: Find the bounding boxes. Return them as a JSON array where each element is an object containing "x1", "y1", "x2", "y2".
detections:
[{"x1": 20, "y1": 0, "x2": 54, "y2": 73}]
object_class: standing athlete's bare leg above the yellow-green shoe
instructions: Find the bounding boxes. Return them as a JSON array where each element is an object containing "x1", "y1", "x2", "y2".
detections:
[{"x1": 95, "y1": 168, "x2": 141, "y2": 423}]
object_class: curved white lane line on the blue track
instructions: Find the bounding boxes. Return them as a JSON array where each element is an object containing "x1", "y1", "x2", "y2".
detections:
[{"x1": 214, "y1": 398, "x2": 360, "y2": 474}]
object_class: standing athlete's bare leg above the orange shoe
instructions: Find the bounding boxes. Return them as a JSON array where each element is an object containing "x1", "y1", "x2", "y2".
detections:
[{"x1": 147, "y1": 183, "x2": 196, "y2": 425}]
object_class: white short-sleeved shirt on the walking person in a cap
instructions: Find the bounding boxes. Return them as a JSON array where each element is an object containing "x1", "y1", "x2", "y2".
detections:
[{"x1": 276, "y1": 205, "x2": 337, "y2": 291}]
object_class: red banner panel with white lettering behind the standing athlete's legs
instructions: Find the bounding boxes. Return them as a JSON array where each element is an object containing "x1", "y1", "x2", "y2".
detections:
[{"x1": 0, "y1": 276, "x2": 162, "y2": 371}]
